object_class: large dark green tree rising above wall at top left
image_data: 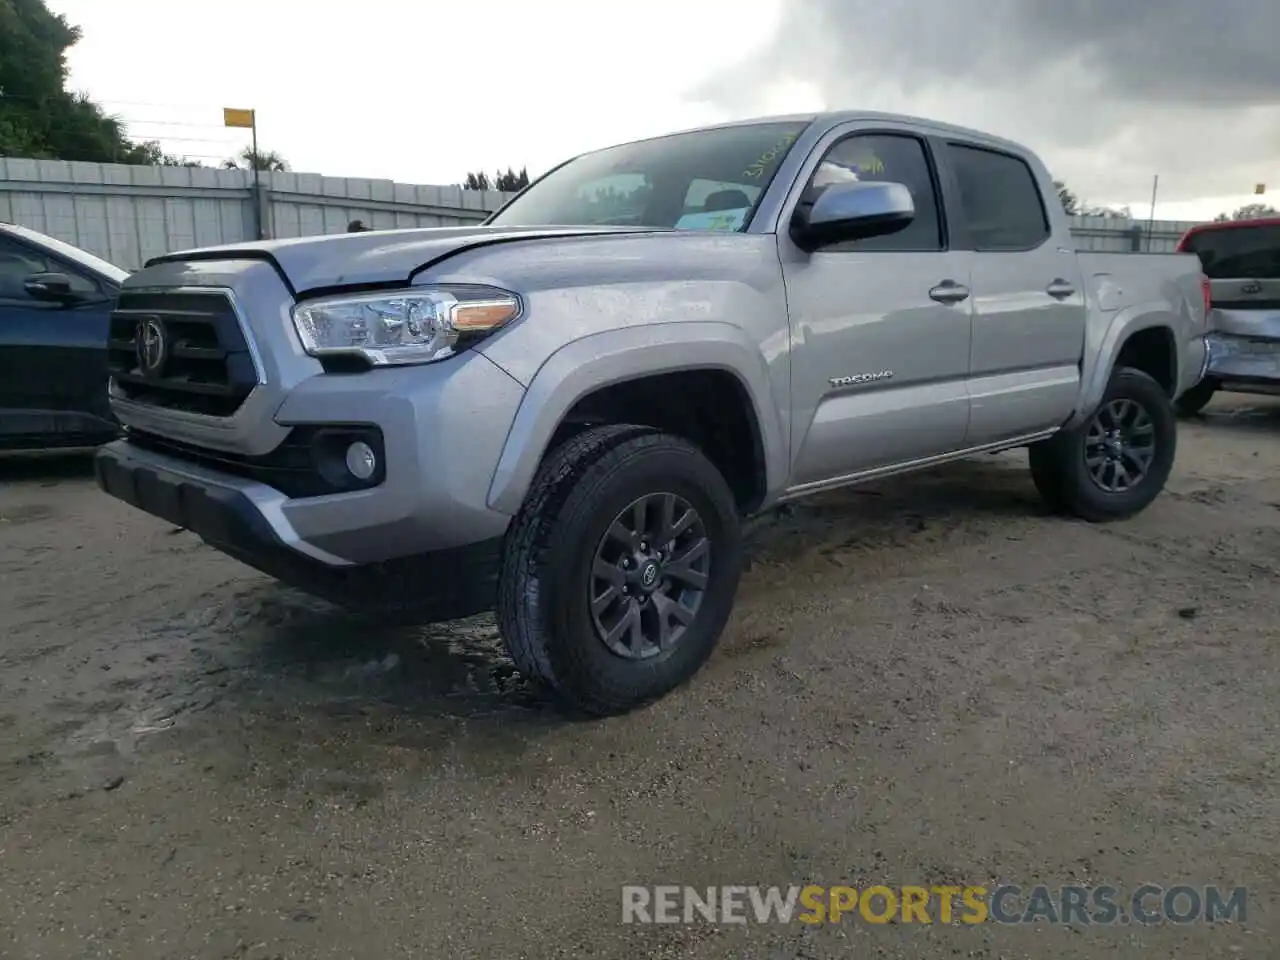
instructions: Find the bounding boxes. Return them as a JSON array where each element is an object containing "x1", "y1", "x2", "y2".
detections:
[{"x1": 0, "y1": 0, "x2": 163, "y2": 164}]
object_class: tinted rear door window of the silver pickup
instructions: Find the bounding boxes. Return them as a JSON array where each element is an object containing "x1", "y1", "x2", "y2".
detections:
[{"x1": 946, "y1": 142, "x2": 1051, "y2": 252}]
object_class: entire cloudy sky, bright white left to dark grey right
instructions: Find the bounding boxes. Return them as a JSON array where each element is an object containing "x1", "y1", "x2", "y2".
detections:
[{"x1": 47, "y1": 0, "x2": 1280, "y2": 220}]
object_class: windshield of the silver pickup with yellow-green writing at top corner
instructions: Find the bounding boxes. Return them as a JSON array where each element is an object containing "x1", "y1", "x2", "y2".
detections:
[{"x1": 489, "y1": 122, "x2": 808, "y2": 230}]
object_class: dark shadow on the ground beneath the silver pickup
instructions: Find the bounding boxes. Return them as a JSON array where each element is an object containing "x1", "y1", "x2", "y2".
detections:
[{"x1": 192, "y1": 457, "x2": 1044, "y2": 732}]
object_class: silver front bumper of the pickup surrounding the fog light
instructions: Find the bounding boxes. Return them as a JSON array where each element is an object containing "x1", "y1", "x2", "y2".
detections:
[{"x1": 104, "y1": 352, "x2": 524, "y2": 567}]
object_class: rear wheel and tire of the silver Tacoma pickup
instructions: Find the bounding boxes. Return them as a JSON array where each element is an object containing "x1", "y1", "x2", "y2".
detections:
[{"x1": 1030, "y1": 367, "x2": 1178, "y2": 524}]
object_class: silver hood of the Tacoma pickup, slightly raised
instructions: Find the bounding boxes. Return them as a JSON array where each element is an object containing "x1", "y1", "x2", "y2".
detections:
[{"x1": 140, "y1": 227, "x2": 654, "y2": 294}]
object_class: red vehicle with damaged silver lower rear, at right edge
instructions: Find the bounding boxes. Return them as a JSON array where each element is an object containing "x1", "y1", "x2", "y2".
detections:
[{"x1": 1178, "y1": 218, "x2": 1280, "y2": 416}]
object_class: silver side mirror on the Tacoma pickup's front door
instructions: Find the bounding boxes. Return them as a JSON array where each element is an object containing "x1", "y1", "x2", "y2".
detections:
[{"x1": 791, "y1": 183, "x2": 915, "y2": 253}]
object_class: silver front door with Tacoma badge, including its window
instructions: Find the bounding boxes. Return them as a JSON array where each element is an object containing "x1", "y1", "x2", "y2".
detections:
[{"x1": 778, "y1": 129, "x2": 973, "y2": 490}]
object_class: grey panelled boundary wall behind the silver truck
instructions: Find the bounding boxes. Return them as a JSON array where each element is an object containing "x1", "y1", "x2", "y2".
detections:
[{"x1": 0, "y1": 157, "x2": 1192, "y2": 270}]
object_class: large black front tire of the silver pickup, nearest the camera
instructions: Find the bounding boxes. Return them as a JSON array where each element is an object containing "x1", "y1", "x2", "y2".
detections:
[{"x1": 497, "y1": 425, "x2": 742, "y2": 716}]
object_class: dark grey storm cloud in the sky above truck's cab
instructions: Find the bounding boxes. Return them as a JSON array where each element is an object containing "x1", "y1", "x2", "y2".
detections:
[{"x1": 695, "y1": 0, "x2": 1280, "y2": 200}]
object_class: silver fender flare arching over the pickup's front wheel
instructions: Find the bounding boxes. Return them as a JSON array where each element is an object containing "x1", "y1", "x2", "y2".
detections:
[{"x1": 488, "y1": 320, "x2": 790, "y2": 515}]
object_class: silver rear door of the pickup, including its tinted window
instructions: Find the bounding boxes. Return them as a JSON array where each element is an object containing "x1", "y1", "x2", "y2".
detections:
[{"x1": 942, "y1": 138, "x2": 1087, "y2": 447}]
